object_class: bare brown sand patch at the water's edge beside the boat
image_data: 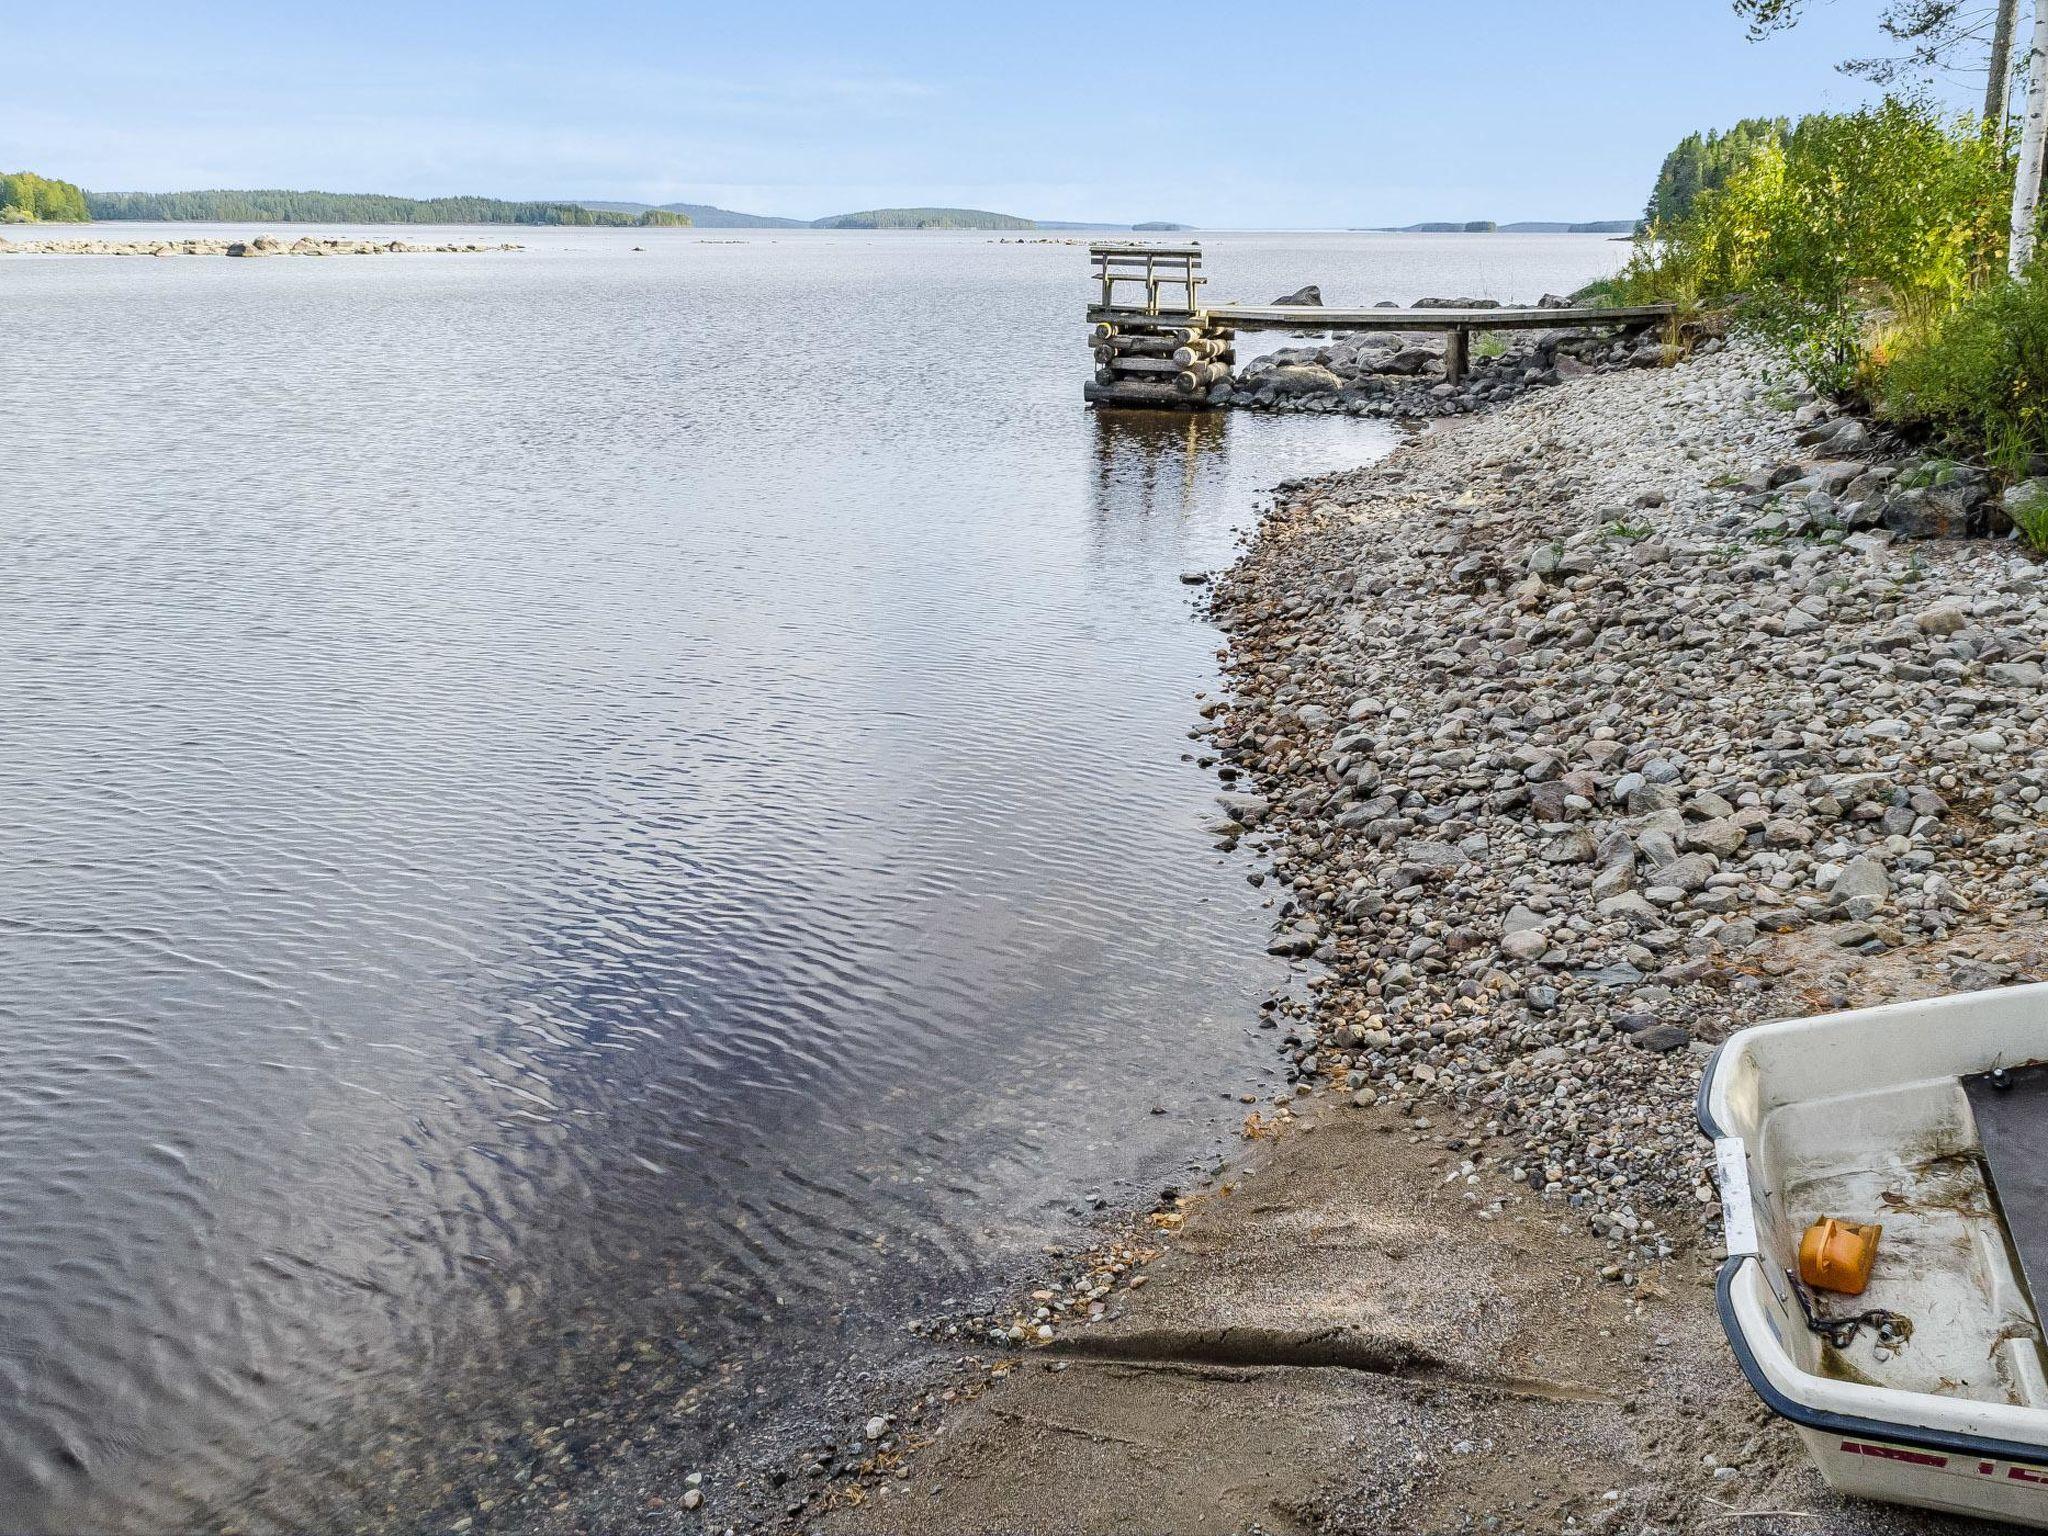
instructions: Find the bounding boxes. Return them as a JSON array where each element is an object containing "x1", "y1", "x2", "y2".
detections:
[{"x1": 813, "y1": 1106, "x2": 1998, "y2": 1536}]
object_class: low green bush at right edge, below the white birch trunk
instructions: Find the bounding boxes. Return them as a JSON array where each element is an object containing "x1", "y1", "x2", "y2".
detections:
[{"x1": 1880, "y1": 260, "x2": 2048, "y2": 475}]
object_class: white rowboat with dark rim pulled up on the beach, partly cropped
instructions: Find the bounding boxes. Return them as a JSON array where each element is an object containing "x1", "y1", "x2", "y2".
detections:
[{"x1": 1700, "y1": 983, "x2": 2048, "y2": 1528}]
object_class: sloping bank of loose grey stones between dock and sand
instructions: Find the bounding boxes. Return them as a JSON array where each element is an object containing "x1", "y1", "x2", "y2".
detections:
[{"x1": 1198, "y1": 344, "x2": 2048, "y2": 1257}]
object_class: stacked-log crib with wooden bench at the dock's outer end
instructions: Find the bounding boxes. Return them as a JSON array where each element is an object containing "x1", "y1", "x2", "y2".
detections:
[{"x1": 1081, "y1": 244, "x2": 1237, "y2": 410}]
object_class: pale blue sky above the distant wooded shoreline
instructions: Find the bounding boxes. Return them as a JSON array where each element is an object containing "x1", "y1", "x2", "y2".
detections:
[{"x1": 0, "y1": 0, "x2": 1974, "y2": 227}]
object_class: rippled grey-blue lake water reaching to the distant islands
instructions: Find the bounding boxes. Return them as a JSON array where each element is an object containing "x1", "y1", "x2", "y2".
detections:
[{"x1": 0, "y1": 225, "x2": 1624, "y2": 1532}]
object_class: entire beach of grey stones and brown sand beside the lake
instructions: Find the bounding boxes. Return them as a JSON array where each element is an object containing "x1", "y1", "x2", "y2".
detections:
[{"x1": 757, "y1": 344, "x2": 2048, "y2": 1536}]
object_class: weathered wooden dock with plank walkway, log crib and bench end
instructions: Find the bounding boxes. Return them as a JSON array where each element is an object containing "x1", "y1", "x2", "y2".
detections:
[{"x1": 1081, "y1": 244, "x2": 1675, "y2": 410}]
